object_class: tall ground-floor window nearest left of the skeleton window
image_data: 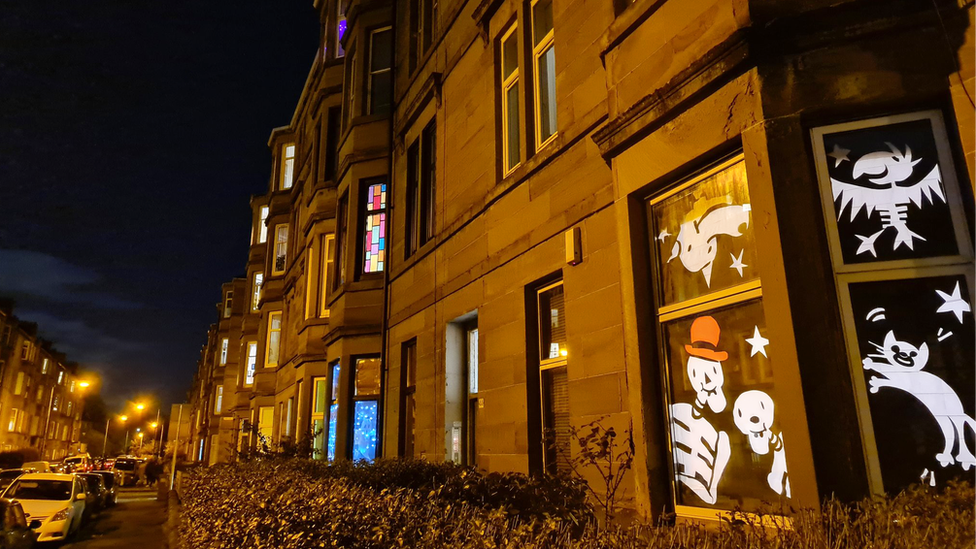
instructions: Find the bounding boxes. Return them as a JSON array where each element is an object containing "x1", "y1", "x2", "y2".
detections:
[{"x1": 536, "y1": 281, "x2": 571, "y2": 474}]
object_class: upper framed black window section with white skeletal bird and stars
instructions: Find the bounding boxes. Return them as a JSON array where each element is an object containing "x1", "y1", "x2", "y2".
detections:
[{"x1": 814, "y1": 113, "x2": 962, "y2": 264}]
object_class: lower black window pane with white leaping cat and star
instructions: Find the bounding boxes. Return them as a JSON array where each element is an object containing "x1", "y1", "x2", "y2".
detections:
[{"x1": 850, "y1": 275, "x2": 976, "y2": 491}]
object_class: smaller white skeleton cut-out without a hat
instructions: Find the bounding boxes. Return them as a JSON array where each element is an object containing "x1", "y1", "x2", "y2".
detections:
[{"x1": 732, "y1": 391, "x2": 791, "y2": 497}]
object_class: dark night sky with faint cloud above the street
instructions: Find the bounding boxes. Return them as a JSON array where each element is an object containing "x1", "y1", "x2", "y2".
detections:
[{"x1": 0, "y1": 0, "x2": 318, "y2": 407}]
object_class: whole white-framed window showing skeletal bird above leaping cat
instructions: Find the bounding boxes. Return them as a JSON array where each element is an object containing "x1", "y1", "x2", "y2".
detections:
[{"x1": 812, "y1": 111, "x2": 976, "y2": 493}]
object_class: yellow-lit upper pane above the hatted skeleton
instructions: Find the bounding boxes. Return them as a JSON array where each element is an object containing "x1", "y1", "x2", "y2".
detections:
[{"x1": 650, "y1": 161, "x2": 759, "y2": 305}]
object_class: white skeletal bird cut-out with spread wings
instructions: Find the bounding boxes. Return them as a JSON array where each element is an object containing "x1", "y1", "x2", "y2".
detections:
[{"x1": 830, "y1": 143, "x2": 946, "y2": 257}]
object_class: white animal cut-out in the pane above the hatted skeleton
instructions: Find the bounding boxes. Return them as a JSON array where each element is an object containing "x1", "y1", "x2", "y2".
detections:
[{"x1": 668, "y1": 198, "x2": 751, "y2": 287}]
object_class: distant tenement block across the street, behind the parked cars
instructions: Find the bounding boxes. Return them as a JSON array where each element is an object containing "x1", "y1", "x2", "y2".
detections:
[{"x1": 0, "y1": 305, "x2": 85, "y2": 461}]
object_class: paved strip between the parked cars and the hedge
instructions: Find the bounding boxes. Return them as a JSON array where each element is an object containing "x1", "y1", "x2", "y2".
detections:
[{"x1": 62, "y1": 488, "x2": 166, "y2": 549}]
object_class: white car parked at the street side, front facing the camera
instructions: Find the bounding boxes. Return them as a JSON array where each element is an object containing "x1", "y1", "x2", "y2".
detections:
[{"x1": 0, "y1": 473, "x2": 85, "y2": 541}]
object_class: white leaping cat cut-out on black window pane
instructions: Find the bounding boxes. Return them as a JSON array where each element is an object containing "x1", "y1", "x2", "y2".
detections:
[{"x1": 862, "y1": 331, "x2": 976, "y2": 471}]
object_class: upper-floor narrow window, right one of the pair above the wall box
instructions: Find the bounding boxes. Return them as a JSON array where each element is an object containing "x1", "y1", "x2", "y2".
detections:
[{"x1": 532, "y1": 0, "x2": 556, "y2": 148}]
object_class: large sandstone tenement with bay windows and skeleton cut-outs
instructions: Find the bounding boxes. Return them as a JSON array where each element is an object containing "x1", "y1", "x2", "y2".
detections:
[{"x1": 192, "y1": 0, "x2": 976, "y2": 517}]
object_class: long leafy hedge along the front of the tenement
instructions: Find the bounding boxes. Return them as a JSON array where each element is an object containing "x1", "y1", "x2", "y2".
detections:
[{"x1": 180, "y1": 460, "x2": 976, "y2": 549}]
